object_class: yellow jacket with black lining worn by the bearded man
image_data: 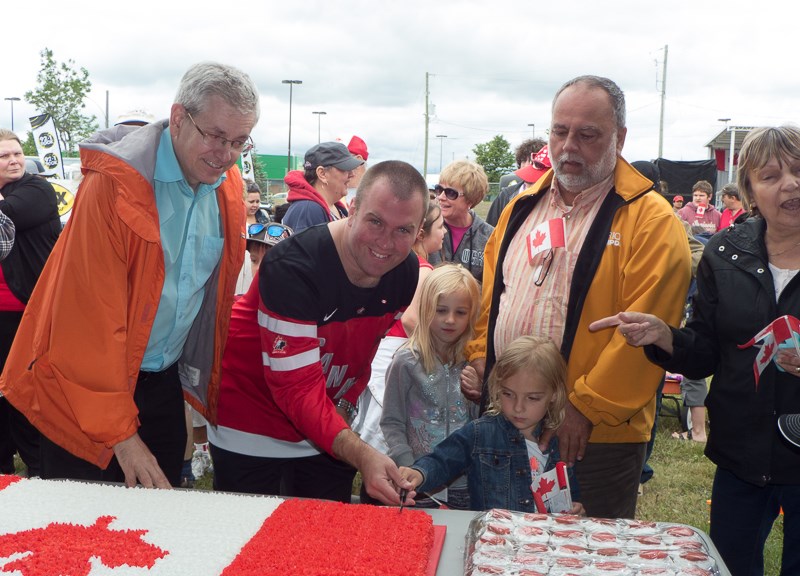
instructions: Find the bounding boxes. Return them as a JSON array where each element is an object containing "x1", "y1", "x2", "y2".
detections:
[{"x1": 467, "y1": 158, "x2": 691, "y2": 443}]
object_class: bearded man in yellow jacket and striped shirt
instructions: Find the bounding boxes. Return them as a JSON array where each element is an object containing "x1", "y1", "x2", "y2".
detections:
[{"x1": 464, "y1": 76, "x2": 690, "y2": 518}]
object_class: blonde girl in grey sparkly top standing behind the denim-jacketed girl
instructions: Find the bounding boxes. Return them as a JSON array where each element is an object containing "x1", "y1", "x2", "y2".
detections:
[{"x1": 381, "y1": 264, "x2": 480, "y2": 510}]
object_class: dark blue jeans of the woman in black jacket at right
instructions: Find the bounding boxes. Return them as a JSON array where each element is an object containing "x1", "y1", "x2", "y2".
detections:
[{"x1": 711, "y1": 468, "x2": 800, "y2": 576}]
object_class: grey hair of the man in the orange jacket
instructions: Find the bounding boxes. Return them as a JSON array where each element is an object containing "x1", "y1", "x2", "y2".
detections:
[{"x1": 175, "y1": 62, "x2": 261, "y2": 122}]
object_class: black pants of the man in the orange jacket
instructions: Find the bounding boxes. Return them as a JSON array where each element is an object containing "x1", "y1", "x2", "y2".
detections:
[{"x1": 42, "y1": 363, "x2": 186, "y2": 486}]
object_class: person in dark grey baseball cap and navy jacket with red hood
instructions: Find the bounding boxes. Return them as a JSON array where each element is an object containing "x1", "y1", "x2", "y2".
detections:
[{"x1": 282, "y1": 142, "x2": 364, "y2": 232}]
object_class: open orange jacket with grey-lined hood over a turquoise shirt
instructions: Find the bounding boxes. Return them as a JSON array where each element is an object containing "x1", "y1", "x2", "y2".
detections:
[{"x1": 0, "y1": 121, "x2": 246, "y2": 468}]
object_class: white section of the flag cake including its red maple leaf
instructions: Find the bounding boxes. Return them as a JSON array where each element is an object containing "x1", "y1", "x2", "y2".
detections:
[{"x1": 0, "y1": 475, "x2": 282, "y2": 576}]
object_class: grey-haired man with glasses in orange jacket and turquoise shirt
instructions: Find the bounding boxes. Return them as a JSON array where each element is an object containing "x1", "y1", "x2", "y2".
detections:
[{"x1": 0, "y1": 63, "x2": 259, "y2": 488}]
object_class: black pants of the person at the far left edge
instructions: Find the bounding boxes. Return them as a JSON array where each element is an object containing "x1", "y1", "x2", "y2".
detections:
[{"x1": 0, "y1": 312, "x2": 40, "y2": 477}]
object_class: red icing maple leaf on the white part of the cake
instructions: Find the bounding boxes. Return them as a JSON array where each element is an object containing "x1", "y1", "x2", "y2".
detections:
[{"x1": 0, "y1": 516, "x2": 168, "y2": 576}]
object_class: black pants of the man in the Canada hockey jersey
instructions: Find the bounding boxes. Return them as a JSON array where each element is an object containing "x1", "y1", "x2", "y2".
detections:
[{"x1": 209, "y1": 443, "x2": 356, "y2": 503}]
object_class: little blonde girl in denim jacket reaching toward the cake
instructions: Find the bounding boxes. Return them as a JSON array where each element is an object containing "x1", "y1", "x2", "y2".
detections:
[{"x1": 400, "y1": 336, "x2": 584, "y2": 514}]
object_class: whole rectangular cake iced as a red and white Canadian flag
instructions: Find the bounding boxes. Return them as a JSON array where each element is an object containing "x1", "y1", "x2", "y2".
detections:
[{"x1": 0, "y1": 474, "x2": 446, "y2": 576}]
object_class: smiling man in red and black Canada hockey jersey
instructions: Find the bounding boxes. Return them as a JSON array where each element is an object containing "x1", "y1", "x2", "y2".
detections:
[{"x1": 209, "y1": 161, "x2": 428, "y2": 504}]
